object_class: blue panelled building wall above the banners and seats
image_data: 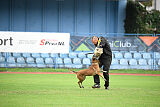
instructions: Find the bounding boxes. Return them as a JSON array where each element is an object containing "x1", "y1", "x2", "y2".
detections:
[{"x1": 0, "y1": 0, "x2": 127, "y2": 33}]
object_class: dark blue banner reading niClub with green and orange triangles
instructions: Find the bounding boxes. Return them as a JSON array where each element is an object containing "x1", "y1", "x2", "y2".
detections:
[{"x1": 71, "y1": 36, "x2": 160, "y2": 52}]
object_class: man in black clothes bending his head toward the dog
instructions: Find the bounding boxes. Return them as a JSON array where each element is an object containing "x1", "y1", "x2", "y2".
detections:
[{"x1": 92, "y1": 36, "x2": 112, "y2": 90}]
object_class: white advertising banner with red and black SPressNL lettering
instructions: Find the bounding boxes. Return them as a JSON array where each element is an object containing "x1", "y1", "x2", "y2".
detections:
[{"x1": 0, "y1": 32, "x2": 70, "y2": 53}]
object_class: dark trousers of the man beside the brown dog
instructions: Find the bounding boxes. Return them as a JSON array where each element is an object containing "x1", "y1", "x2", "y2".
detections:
[{"x1": 93, "y1": 56, "x2": 112, "y2": 87}]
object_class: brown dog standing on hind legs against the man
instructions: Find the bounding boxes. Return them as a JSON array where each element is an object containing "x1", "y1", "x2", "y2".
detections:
[{"x1": 70, "y1": 56, "x2": 106, "y2": 88}]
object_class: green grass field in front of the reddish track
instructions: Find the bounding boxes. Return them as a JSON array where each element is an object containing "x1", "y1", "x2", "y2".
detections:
[{"x1": 0, "y1": 74, "x2": 160, "y2": 107}]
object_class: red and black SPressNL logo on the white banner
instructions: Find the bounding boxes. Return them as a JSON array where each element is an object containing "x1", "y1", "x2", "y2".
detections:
[{"x1": 40, "y1": 39, "x2": 64, "y2": 46}]
